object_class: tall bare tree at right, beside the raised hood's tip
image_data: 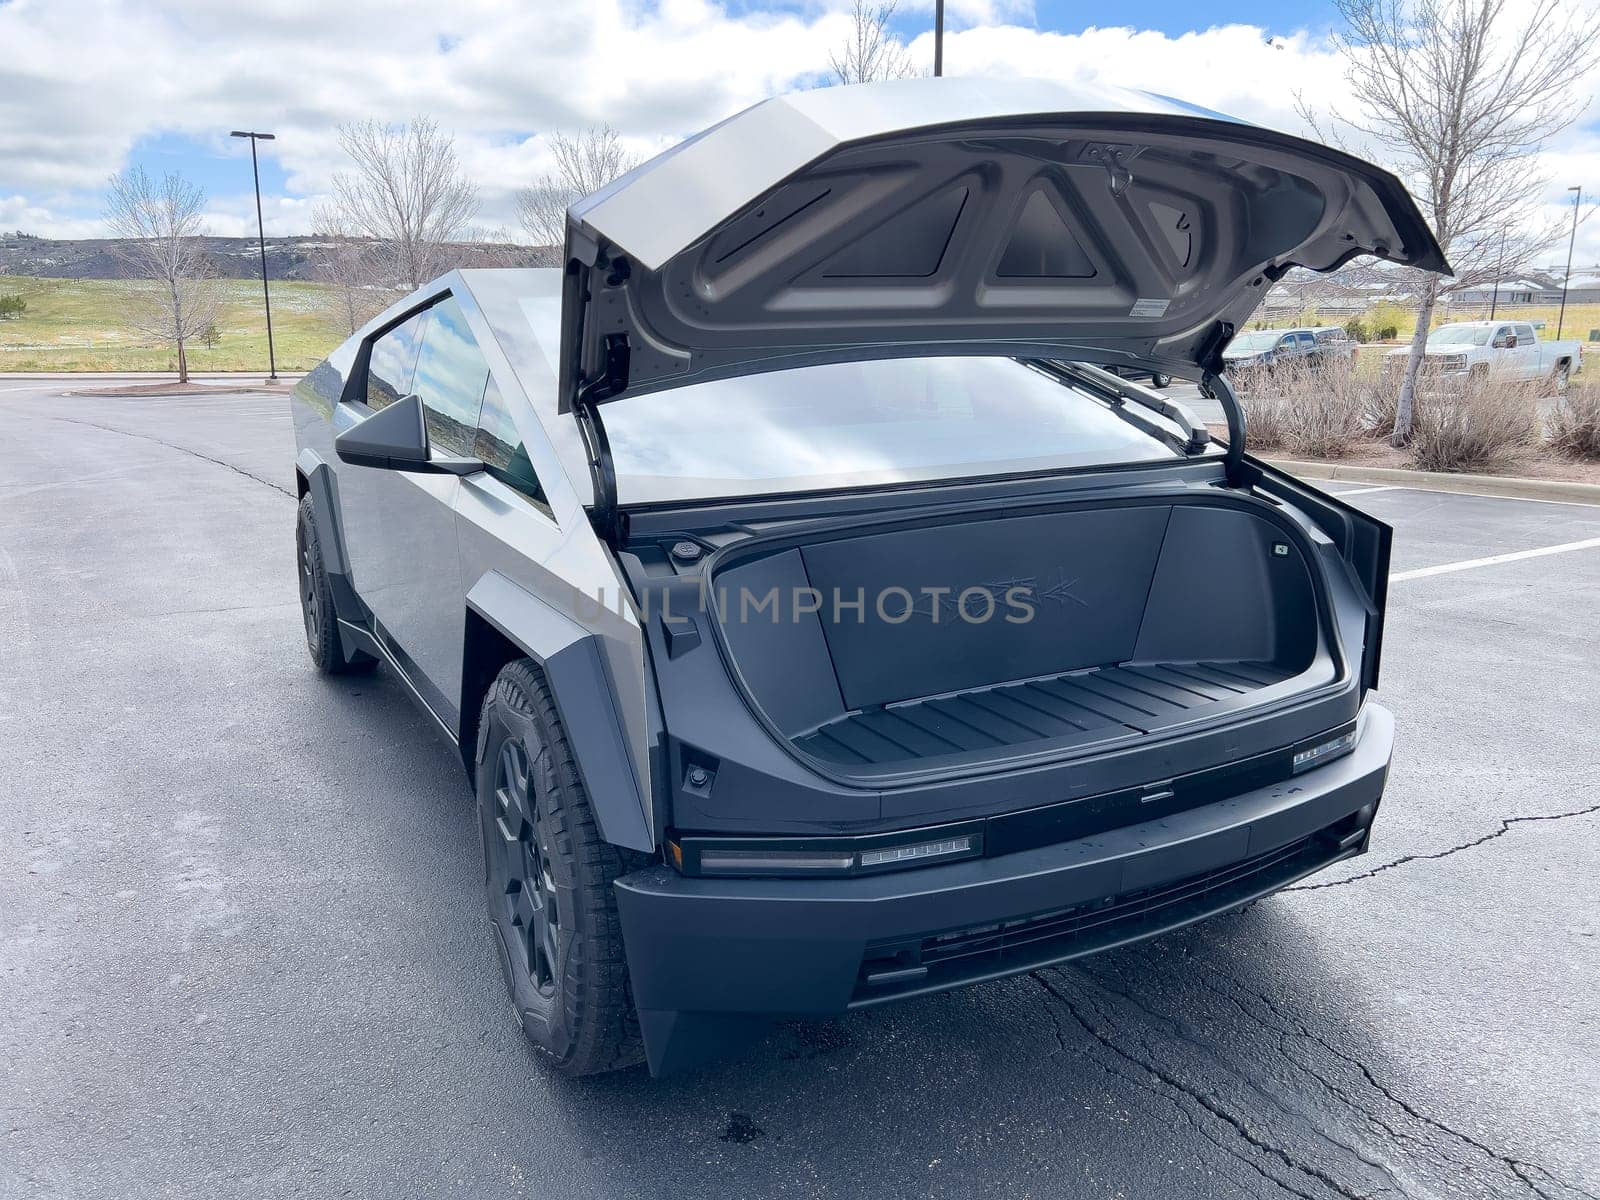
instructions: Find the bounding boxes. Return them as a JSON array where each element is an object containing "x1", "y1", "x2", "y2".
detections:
[{"x1": 1301, "y1": 0, "x2": 1600, "y2": 446}]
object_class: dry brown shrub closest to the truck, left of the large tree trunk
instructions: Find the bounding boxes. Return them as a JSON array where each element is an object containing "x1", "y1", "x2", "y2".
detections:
[{"x1": 1243, "y1": 360, "x2": 1373, "y2": 458}]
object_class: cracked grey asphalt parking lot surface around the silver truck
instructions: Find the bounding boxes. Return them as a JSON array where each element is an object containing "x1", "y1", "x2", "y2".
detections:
[{"x1": 0, "y1": 379, "x2": 1600, "y2": 1200}]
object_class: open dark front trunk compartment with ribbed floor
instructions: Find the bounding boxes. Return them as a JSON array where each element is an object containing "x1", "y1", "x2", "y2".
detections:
[{"x1": 715, "y1": 498, "x2": 1336, "y2": 774}]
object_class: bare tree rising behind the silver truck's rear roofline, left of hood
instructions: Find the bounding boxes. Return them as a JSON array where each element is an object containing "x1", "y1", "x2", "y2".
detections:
[{"x1": 333, "y1": 117, "x2": 478, "y2": 291}]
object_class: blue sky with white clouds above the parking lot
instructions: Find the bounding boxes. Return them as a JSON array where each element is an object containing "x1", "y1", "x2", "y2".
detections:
[{"x1": 0, "y1": 0, "x2": 1600, "y2": 266}]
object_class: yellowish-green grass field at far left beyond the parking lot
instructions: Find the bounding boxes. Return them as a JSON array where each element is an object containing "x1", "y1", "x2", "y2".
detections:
[{"x1": 0, "y1": 275, "x2": 346, "y2": 371}]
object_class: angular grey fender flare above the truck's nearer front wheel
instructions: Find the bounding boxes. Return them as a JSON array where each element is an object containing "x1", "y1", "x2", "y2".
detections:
[{"x1": 467, "y1": 571, "x2": 656, "y2": 853}]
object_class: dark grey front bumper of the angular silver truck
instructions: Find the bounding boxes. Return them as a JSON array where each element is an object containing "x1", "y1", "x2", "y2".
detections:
[{"x1": 616, "y1": 704, "x2": 1394, "y2": 1074}]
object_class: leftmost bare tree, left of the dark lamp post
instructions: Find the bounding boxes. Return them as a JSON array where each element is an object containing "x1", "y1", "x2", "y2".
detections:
[{"x1": 106, "y1": 166, "x2": 221, "y2": 384}]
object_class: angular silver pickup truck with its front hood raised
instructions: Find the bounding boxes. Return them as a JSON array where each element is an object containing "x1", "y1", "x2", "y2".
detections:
[{"x1": 293, "y1": 78, "x2": 1445, "y2": 1074}]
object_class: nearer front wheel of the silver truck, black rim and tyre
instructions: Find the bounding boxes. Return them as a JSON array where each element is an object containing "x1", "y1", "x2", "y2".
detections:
[{"x1": 475, "y1": 659, "x2": 643, "y2": 1075}]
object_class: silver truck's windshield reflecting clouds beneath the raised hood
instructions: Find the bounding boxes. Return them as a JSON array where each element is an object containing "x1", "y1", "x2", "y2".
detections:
[{"x1": 603, "y1": 358, "x2": 1178, "y2": 504}]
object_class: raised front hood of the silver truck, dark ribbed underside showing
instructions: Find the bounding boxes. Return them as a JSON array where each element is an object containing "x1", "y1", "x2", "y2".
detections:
[{"x1": 560, "y1": 78, "x2": 1448, "y2": 411}]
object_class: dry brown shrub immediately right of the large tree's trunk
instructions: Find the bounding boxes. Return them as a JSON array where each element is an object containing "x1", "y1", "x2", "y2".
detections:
[{"x1": 1411, "y1": 376, "x2": 1546, "y2": 470}]
